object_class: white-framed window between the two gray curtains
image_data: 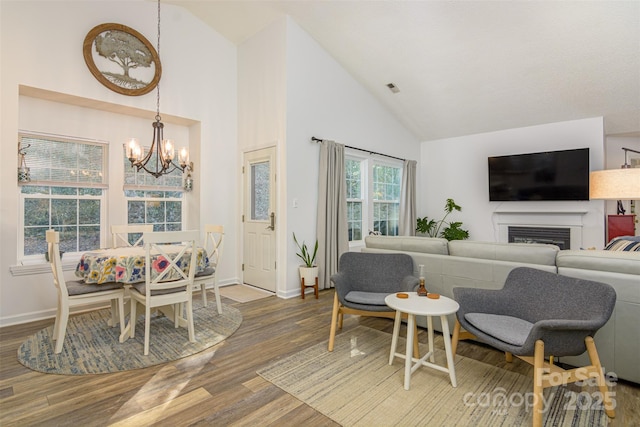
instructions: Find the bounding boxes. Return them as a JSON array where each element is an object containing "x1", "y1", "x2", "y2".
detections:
[{"x1": 345, "y1": 153, "x2": 402, "y2": 242}]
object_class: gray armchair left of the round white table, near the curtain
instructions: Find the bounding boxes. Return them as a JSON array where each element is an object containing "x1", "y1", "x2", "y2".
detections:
[{"x1": 329, "y1": 252, "x2": 418, "y2": 351}]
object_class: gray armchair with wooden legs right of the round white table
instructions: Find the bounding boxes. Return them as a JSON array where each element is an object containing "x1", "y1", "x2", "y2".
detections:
[{"x1": 452, "y1": 267, "x2": 616, "y2": 426}]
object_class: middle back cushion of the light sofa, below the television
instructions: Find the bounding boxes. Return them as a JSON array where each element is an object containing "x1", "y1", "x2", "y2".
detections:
[{"x1": 449, "y1": 240, "x2": 560, "y2": 265}]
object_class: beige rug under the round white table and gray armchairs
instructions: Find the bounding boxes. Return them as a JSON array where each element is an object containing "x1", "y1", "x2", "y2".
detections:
[{"x1": 258, "y1": 326, "x2": 608, "y2": 427}]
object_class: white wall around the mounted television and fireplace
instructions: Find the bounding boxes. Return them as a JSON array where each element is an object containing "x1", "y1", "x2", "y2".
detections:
[{"x1": 418, "y1": 117, "x2": 604, "y2": 248}]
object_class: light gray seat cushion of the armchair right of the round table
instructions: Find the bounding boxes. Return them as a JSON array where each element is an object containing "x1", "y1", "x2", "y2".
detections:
[{"x1": 464, "y1": 313, "x2": 533, "y2": 346}]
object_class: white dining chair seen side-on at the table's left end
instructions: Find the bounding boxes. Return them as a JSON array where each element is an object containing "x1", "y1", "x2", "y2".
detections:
[{"x1": 46, "y1": 230, "x2": 124, "y2": 353}]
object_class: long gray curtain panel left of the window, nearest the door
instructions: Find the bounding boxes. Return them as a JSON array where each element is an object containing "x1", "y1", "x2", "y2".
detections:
[{"x1": 316, "y1": 140, "x2": 349, "y2": 289}]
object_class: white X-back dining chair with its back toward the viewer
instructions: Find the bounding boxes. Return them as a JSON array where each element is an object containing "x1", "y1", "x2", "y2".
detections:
[{"x1": 129, "y1": 231, "x2": 199, "y2": 356}]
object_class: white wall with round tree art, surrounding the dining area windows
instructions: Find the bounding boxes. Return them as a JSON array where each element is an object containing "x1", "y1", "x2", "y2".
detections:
[{"x1": 0, "y1": 0, "x2": 238, "y2": 325}]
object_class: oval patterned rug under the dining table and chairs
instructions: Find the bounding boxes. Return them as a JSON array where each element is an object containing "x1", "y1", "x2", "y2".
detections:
[{"x1": 18, "y1": 298, "x2": 242, "y2": 375}]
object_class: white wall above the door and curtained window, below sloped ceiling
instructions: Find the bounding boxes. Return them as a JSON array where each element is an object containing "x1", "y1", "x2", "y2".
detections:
[{"x1": 238, "y1": 18, "x2": 419, "y2": 297}]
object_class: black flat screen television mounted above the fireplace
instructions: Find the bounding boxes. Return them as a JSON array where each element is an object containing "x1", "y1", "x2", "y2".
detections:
[{"x1": 489, "y1": 148, "x2": 589, "y2": 202}]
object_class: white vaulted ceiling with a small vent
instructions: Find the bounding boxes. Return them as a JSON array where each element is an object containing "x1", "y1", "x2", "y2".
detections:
[{"x1": 168, "y1": 0, "x2": 640, "y2": 141}]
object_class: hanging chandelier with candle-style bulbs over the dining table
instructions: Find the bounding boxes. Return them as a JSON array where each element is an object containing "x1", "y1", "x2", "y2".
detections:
[{"x1": 126, "y1": 0, "x2": 189, "y2": 178}]
